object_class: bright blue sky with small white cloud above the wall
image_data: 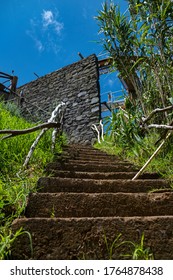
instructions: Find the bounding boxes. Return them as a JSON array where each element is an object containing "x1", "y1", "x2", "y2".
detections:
[{"x1": 0, "y1": 0, "x2": 127, "y2": 96}]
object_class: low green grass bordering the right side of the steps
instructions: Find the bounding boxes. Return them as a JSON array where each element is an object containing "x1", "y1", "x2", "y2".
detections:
[{"x1": 95, "y1": 133, "x2": 173, "y2": 182}]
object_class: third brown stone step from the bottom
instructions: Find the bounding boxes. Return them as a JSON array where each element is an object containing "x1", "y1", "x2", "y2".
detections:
[{"x1": 37, "y1": 177, "x2": 170, "y2": 193}]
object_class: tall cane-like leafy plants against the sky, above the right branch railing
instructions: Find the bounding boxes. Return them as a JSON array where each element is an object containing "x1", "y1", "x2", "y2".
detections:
[{"x1": 96, "y1": 0, "x2": 173, "y2": 117}]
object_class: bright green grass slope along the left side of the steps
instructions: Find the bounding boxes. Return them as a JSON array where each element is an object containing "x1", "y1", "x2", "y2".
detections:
[{"x1": 0, "y1": 102, "x2": 66, "y2": 259}]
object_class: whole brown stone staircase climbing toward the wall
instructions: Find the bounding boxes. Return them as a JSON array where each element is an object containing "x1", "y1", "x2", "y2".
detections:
[{"x1": 12, "y1": 145, "x2": 173, "y2": 260}]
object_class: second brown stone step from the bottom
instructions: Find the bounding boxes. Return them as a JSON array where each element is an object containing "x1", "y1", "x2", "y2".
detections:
[{"x1": 25, "y1": 192, "x2": 173, "y2": 218}]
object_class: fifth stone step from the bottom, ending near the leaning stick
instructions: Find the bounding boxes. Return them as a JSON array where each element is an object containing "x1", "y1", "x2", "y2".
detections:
[{"x1": 46, "y1": 162, "x2": 138, "y2": 172}]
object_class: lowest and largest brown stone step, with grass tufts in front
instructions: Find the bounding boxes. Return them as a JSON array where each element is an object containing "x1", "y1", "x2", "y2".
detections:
[{"x1": 11, "y1": 216, "x2": 173, "y2": 260}]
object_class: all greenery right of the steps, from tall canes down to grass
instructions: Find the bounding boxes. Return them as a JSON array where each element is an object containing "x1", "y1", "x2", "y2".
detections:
[{"x1": 96, "y1": 0, "x2": 173, "y2": 179}]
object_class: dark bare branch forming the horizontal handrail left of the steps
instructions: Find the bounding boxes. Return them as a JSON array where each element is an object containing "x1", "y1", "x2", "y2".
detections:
[{"x1": 0, "y1": 122, "x2": 61, "y2": 140}]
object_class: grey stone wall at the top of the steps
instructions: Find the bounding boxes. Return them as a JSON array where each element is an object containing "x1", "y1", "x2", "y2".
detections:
[{"x1": 17, "y1": 55, "x2": 100, "y2": 144}]
